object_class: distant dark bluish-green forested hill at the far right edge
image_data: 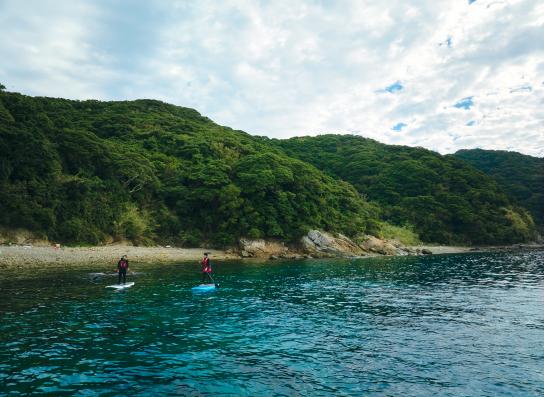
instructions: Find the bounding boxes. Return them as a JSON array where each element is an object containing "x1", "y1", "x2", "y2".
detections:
[{"x1": 454, "y1": 149, "x2": 544, "y2": 231}]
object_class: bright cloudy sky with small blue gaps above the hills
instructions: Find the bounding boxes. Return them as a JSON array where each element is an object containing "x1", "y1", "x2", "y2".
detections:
[{"x1": 0, "y1": 0, "x2": 544, "y2": 157}]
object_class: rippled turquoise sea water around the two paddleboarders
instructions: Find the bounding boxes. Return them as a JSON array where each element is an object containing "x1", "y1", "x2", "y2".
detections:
[{"x1": 0, "y1": 251, "x2": 544, "y2": 396}]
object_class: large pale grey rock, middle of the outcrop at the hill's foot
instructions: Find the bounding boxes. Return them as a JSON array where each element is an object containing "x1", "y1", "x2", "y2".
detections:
[{"x1": 300, "y1": 230, "x2": 363, "y2": 257}]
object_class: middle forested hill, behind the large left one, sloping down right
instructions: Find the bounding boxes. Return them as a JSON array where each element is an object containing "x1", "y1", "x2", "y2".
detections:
[{"x1": 272, "y1": 135, "x2": 534, "y2": 244}]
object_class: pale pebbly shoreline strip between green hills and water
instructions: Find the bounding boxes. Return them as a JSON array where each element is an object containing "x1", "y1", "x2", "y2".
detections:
[{"x1": 0, "y1": 244, "x2": 544, "y2": 269}]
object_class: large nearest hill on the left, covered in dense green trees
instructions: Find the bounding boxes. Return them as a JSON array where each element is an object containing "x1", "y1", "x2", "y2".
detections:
[{"x1": 0, "y1": 92, "x2": 377, "y2": 245}]
